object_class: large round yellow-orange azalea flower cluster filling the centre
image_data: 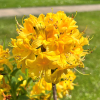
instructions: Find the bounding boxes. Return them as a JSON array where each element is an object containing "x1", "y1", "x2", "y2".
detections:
[{"x1": 11, "y1": 11, "x2": 89, "y2": 84}]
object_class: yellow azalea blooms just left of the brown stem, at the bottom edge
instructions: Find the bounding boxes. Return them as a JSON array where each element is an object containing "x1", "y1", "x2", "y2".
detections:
[{"x1": 30, "y1": 78, "x2": 52, "y2": 100}]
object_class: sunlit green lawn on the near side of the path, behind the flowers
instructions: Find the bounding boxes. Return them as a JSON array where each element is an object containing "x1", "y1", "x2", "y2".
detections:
[{"x1": 0, "y1": 11, "x2": 100, "y2": 100}]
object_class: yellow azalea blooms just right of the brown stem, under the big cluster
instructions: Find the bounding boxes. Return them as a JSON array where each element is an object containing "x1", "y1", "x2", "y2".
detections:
[{"x1": 56, "y1": 69, "x2": 76, "y2": 98}]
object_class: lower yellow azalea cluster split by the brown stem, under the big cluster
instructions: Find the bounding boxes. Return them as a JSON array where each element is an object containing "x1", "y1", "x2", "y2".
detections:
[{"x1": 30, "y1": 69, "x2": 76, "y2": 100}]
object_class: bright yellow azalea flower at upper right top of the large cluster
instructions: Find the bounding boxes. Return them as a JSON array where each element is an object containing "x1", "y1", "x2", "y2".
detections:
[{"x1": 57, "y1": 11, "x2": 78, "y2": 33}]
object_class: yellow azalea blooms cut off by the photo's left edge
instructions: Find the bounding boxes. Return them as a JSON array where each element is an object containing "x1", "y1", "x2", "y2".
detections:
[{"x1": 0, "y1": 45, "x2": 12, "y2": 100}]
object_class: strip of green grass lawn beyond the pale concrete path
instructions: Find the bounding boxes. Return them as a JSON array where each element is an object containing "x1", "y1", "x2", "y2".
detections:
[{"x1": 0, "y1": 0, "x2": 100, "y2": 8}]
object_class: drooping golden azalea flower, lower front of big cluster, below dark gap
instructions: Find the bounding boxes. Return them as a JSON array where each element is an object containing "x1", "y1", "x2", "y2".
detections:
[{"x1": 26, "y1": 53, "x2": 58, "y2": 77}]
